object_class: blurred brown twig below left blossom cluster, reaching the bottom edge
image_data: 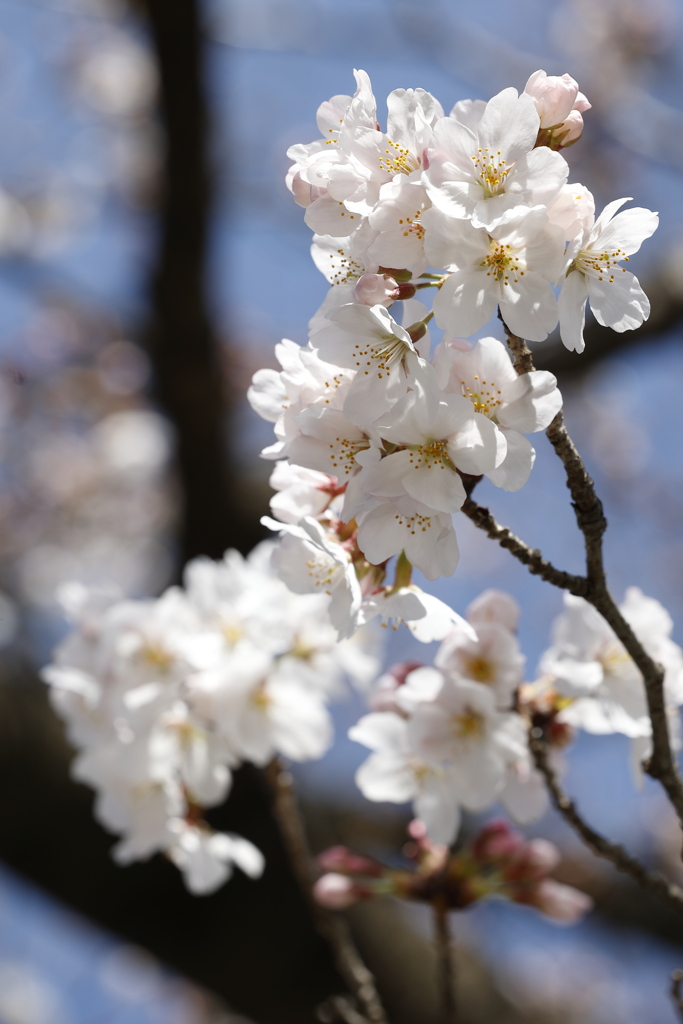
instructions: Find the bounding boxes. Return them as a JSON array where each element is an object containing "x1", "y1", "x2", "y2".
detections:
[{"x1": 265, "y1": 758, "x2": 388, "y2": 1024}]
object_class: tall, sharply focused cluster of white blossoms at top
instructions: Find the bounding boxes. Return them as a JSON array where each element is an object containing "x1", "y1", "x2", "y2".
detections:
[{"x1": 249, "y1": 72, "x2": 657, "y2": 610}]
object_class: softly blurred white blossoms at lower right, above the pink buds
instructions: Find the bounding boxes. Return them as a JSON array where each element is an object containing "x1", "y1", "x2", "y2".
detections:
[{"x1": 349, "y1": 588, "x2": 683, "y2": 845}]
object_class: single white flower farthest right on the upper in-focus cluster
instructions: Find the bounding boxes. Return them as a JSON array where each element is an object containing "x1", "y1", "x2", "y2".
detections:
[{"x1": 558, "y1": 199, "x2": 659, "y2": 352}]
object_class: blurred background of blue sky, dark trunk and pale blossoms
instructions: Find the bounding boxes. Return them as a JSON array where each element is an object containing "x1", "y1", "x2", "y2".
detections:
[{"x1": 0, "y1": 0, "x2": 683, "y2": 1024}]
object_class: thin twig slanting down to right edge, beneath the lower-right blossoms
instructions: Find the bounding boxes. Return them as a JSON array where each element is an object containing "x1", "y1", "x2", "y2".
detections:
[{"x1": 529, "y1": 729, "x2": 683, "y2": 913}]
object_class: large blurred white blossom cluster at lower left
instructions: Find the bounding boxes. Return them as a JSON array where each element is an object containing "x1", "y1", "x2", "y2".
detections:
[{"x1": 43, "y1": 542, "x2": 378, "y2": 893}]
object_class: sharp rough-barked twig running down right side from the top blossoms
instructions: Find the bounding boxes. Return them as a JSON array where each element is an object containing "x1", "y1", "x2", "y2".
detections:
[{"x1": 501, "y1": 317, "x2": 683, "y2": 824}]
